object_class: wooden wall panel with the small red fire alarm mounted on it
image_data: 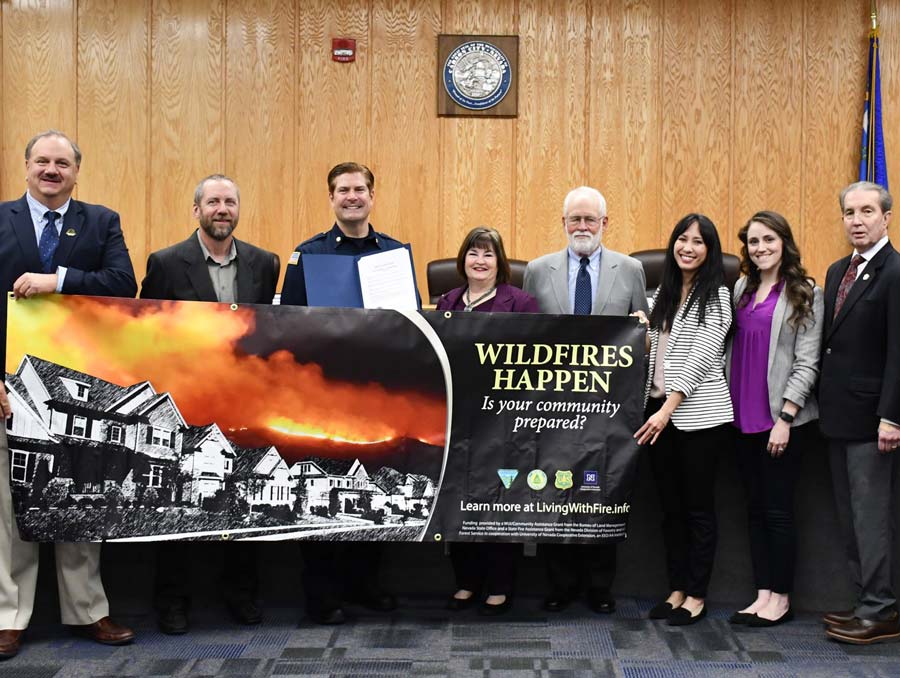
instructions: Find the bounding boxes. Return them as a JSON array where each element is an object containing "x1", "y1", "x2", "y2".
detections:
[{"x1": 298, "y1": 0, "x2": 370, "y2": 248}]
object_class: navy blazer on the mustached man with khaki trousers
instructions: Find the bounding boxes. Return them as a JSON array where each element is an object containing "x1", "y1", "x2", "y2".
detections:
[{"x1": 0, "y1": 195, "x2": 137, "y2": 372}]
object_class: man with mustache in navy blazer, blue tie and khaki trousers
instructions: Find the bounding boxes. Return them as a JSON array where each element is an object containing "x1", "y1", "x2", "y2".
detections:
[{"x1": 0, "y1": 130, "x2": 137, "y2": 658}]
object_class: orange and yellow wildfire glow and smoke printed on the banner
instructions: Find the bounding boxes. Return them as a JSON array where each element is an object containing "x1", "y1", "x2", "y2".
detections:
[{"x1": 6, "y1": 297, "x2": 446, "y2": 454}]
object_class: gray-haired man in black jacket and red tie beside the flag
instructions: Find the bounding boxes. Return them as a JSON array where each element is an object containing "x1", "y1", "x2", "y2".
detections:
[{"x1": 819, "y1": 182, "x2": 900, "y2": 645}]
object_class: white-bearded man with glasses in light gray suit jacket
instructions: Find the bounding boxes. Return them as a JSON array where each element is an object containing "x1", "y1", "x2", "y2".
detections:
[{"x1": 523, "y1": 186, "x2": 649, "y2": 613}]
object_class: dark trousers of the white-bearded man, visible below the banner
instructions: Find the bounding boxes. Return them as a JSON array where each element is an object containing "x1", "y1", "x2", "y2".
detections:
[{"x1": 541, "y1": 544, "x2": 616, "y2": 596}]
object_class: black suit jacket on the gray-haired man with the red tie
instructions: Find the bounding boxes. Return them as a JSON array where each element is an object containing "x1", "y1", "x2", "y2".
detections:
[{"x1": 819, "y1": 243, "x2": 900, "y2": 440}]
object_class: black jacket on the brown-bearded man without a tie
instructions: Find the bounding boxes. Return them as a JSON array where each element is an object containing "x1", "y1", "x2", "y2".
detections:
[{"x1": 141, "y1": 231, "x2": 280, "y2": 304}]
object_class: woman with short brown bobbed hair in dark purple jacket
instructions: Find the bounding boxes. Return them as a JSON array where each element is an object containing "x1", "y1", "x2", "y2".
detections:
[{"x1": 437, "y1": 226, "x2": 540, "y2": 615}]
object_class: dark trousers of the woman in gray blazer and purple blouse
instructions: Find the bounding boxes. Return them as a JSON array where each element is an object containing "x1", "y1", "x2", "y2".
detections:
[{"x1": 735, "y1": 424, "x2": 810, "y2": 593}]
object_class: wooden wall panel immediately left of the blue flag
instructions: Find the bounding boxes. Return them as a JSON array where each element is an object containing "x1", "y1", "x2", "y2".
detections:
[{"x1": 800, "y1": 0, "x2": 872, "y2": 283}]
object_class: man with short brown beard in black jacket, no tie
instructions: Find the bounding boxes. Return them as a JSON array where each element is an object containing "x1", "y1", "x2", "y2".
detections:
[{"x1": 141, "y1": 174, "x2": 280, "y2": 634}]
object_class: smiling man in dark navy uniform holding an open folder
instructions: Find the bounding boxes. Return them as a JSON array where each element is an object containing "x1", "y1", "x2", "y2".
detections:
[{"x1": 281, "y1": 162, "x2": 403, "y2": 624}]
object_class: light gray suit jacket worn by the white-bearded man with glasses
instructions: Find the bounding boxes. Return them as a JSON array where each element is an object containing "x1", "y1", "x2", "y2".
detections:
[{"x1": 522, "y1": 247, "x2": 648, "y2": 315}]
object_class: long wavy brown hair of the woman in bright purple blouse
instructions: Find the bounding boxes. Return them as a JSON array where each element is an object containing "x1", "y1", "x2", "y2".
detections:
[{"x1": 738, "y1": 210, "x2": 815, "y2": 329}]
